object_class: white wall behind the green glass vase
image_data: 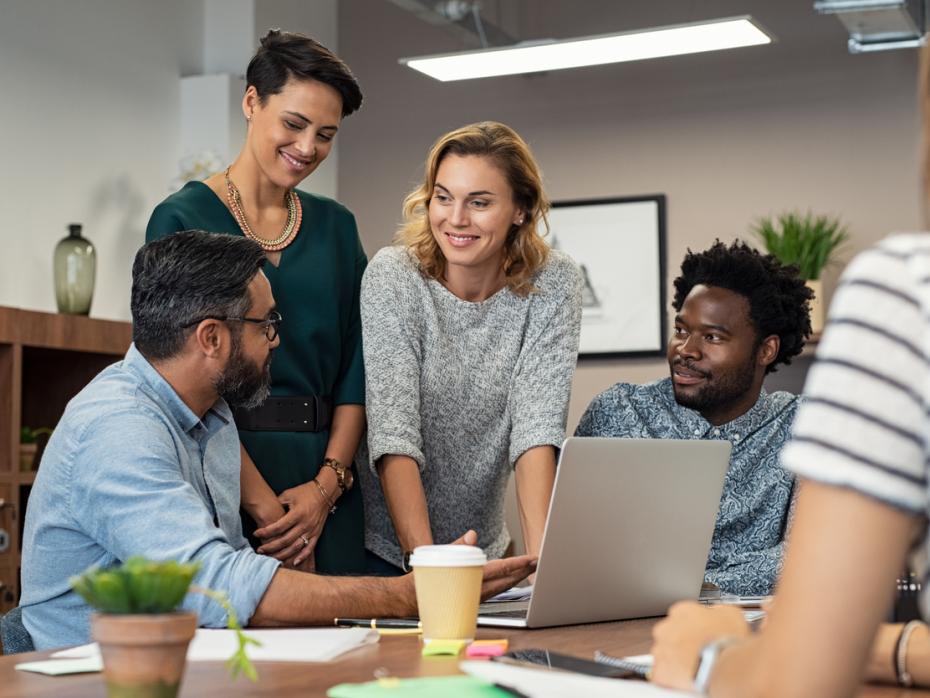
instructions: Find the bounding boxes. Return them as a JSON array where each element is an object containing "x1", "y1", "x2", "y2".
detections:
[{"x1": 0, "y1": 0, "x2": 203, "y2": 318}]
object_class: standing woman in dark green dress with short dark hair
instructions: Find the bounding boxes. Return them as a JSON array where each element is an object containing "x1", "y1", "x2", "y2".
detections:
[{"x1": 146, "y1": 30, "x2": 366, "y2": 573}]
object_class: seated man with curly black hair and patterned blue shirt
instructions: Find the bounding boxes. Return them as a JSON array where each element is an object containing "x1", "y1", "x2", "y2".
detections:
[{"x1": 575, "y1": 240, "x2": 813, "y2": 595}]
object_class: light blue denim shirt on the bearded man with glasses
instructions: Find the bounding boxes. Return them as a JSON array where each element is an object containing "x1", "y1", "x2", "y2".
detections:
[{"x1": 20, "y1": 346, "x2": 279, "y2": 650}]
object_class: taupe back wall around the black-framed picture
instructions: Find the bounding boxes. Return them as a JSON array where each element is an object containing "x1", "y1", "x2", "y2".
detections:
[{"x1": 339, "y1": 0, "x2": 919, "y2": 428}]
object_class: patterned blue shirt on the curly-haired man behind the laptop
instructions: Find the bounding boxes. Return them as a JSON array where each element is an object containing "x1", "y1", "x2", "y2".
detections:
[{"x1": 575, "y1": 378, "x2": 800, "y2": 594}]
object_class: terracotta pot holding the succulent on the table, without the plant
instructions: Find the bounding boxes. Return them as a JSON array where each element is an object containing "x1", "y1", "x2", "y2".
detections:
[{"x1": 91, "y1": 613, "x2": 197, "y2": 698}]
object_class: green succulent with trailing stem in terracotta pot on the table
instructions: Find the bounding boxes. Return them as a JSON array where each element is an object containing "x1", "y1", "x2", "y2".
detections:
[{"x1": 70, "y1": 557, "x2": 258, "y2": 698}]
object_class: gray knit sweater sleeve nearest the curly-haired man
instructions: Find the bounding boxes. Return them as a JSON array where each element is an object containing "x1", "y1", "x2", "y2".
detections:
[{"x1": 510, "y1": 256, "x2": 582, "y2": 466}]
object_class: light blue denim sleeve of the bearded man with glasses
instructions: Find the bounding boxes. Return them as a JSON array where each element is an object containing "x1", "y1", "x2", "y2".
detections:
[{"x1": 71, "y1": 405, "x2": 279, "y2": 627}]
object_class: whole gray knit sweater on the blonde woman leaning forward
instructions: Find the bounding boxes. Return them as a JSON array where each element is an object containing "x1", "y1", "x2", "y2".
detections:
[{"x1": 359, "y1": 247, "x2": 582, "y2": 565}]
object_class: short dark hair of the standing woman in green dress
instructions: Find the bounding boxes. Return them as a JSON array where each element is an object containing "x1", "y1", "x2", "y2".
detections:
[{"x1": 245, "y1": 29, "x2": 362, "y2": 117}]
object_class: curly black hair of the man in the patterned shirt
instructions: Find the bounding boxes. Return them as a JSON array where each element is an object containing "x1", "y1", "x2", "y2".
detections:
[{"x1": 672, "y1": 240, "x2": 814, "y2": 373}]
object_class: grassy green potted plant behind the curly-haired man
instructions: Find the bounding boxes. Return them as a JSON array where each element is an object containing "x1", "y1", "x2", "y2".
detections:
[{"x1": 753, "y1": 211, "x2": 849, "y2": 335}]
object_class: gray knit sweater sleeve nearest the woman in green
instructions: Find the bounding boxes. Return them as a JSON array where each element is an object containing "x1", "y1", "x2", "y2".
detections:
[{"x1": 361, "y1": 248, "x2": 426, "y2": 476}]
